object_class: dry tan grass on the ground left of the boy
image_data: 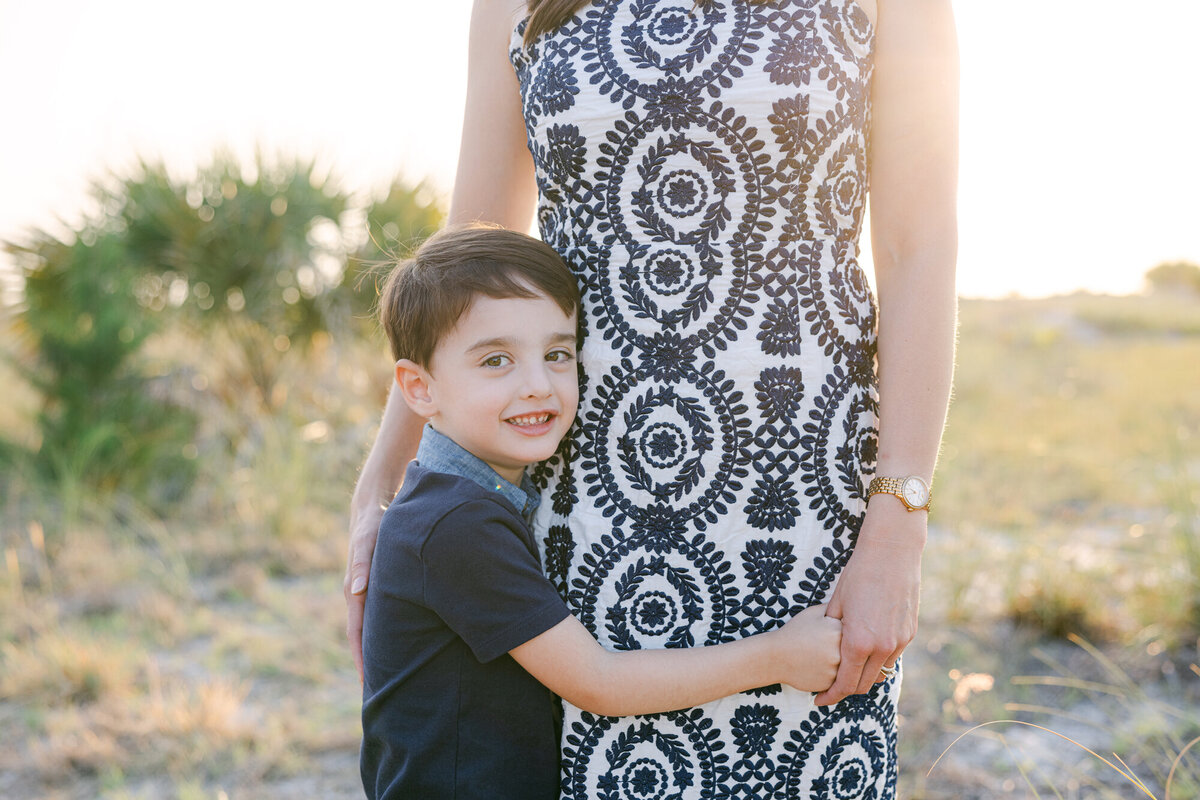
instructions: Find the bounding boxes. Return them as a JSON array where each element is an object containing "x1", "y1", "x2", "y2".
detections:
[{"x1": 0, "y1": 331, "x2": 374, "y2": 798}]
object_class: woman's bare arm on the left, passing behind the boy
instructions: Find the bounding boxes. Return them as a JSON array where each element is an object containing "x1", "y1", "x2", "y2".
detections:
[{"x1": 342, "y1": 0, "x2": 536, "y2": 678}]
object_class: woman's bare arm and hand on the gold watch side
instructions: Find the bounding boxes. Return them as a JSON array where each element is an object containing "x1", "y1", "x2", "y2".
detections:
[{"x1": 816, "y1": 0, "x2": 958, "y2": 704}]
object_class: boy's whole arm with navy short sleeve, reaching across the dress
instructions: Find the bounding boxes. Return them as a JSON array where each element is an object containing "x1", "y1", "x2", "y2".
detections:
[{"x1": 420, "y1": 496, "x2": 841, "y2": 716}]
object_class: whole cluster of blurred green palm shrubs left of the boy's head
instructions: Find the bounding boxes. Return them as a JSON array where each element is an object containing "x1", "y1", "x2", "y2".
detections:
[{"x1": 0, "y1": 152, "x2": 444, "y2": 510}]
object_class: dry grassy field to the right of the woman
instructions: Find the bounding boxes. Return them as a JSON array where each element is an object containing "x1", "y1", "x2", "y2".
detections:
[{"x1": 900, "y1": 296, "x2": 1200, "y2": 800}]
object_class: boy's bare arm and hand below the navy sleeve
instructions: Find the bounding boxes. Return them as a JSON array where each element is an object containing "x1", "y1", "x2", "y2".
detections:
[{"x1": 510, "y1": 606, "x2": 841, "y2": 716}]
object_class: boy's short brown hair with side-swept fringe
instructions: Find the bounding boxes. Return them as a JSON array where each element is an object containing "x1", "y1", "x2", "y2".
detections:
[{"x1": 379, "y1": 223, "x2": 580, "y2": 368}]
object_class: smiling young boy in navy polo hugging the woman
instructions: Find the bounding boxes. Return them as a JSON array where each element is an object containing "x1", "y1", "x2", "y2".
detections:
[{"x1": 361, "y1": 225, "x2": 841, "y2": 800}]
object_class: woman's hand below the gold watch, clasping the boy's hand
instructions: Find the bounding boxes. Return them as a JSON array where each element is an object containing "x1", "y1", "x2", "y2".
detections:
[{"x1": 815, "y1": 503, "x2": 928, "y2": 705}]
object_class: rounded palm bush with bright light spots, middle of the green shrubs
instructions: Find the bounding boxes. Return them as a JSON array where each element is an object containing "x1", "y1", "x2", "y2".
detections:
[{"x1": 101, "y1": 155, "x2": 349, "y2": 405}]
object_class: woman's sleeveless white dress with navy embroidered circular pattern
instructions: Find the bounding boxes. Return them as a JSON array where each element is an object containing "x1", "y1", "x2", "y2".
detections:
[{"x1": 511, "y1": 0, "x2": 899, "y2": 800}]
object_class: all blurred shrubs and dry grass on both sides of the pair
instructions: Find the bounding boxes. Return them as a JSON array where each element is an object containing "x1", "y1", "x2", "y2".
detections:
[{"x1": 0, "y1": 159, "x2": 1200, "y2": 800}]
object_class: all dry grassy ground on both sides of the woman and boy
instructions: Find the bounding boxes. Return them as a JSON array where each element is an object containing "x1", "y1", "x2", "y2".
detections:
[{"x1": 0, "y1": 297, "x2": 1200, "y2": 800}]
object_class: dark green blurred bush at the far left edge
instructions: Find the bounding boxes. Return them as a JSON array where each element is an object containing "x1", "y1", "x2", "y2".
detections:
[{"x1": 6, "y1": 231, "x2": 196, "y2": 506}]
